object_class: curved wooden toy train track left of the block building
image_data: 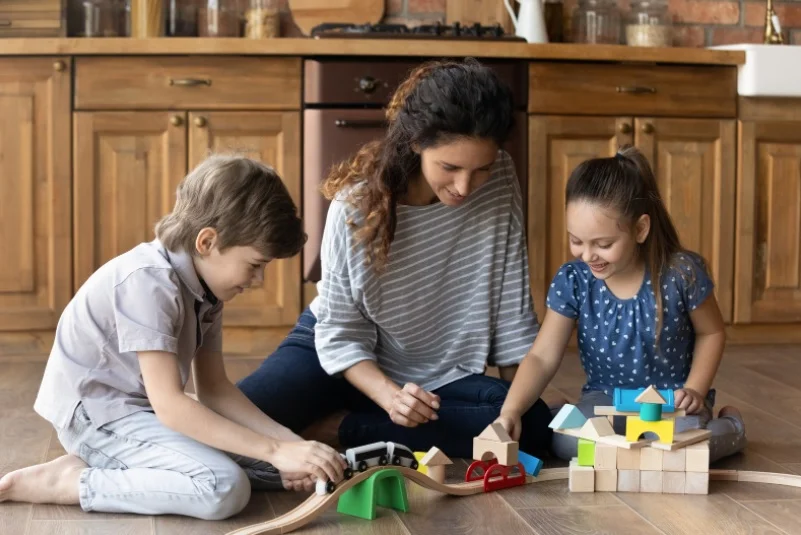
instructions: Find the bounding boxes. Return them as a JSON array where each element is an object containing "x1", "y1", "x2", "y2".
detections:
[{"x1": 227, "y1": 466, "x2": 568, "y2": 535}]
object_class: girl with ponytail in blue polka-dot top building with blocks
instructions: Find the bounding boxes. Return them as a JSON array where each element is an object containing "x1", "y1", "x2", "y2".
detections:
[{"x1": 498, "y1": 148, "x2": 745, "y2": 461}]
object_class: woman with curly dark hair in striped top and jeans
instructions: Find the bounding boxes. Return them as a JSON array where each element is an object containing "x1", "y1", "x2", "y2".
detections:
[{"x1": 239, "y1": 60, "x2": 550, "y2": 457}]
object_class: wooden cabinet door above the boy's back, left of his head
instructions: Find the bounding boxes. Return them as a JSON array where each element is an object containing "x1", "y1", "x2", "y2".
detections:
[{"x1": 74, "y1": 111, "x2": 186, "y2": 290}]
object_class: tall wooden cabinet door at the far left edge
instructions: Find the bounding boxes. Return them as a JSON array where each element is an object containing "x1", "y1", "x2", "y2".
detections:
[{"x1": 0, "y1": 58, "x2": 72, "y2": 331}]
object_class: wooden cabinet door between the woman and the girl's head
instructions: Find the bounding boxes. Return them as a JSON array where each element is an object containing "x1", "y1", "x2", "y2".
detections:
[{"x1": 527, "y1": 116, "x2": 633, "y2": 314}]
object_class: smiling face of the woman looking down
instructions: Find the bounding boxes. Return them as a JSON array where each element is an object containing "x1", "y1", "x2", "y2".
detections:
[{"x1": 420, "y1": 137, "x2": 498, "y2": 206}]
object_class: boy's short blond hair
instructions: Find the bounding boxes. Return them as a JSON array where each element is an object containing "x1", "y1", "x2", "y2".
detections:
[{"x1": 156, "y1": 155, "x2": 306, "y2": 259}]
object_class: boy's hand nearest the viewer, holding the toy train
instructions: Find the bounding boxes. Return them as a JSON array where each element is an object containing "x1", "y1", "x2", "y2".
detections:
[{"x1": 264, "y1": 440, "x2": 345, "y2": 488}]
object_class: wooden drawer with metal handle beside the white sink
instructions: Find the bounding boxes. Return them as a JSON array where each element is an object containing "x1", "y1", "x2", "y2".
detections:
[{"x1": 528, "y1": 63, "x2": 737, "y2": 117}]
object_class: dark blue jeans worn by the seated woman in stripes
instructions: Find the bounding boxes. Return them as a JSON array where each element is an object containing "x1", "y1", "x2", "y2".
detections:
[{"x1": 238, "y1": 309, "x2": 551, "y2": 458}]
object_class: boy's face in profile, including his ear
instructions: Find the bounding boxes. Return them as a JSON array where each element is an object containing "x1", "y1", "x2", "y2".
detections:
[{"x1": 195, "y1": 229, "x2": 269, "y2": 301}]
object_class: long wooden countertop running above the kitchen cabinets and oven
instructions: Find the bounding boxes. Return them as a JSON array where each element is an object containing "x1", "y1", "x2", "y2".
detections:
[{"x1": 0, "y1": 37, "x2": 745, "y2": 65}]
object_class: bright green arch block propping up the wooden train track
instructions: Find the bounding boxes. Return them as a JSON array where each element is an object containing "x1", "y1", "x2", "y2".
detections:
[{"x1": 337, "y1": 468, "x2": 409, "y2": 520}]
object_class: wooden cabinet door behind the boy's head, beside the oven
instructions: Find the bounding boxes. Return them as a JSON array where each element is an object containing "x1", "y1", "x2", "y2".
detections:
[{"x1": 189, "y1": 112, "x2": 301, "y2": 327}]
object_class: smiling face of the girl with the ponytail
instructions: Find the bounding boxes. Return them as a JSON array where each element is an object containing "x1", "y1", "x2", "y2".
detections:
[{"x1": 566, "y1": 201, "x2": 650, "y2": 280}]
